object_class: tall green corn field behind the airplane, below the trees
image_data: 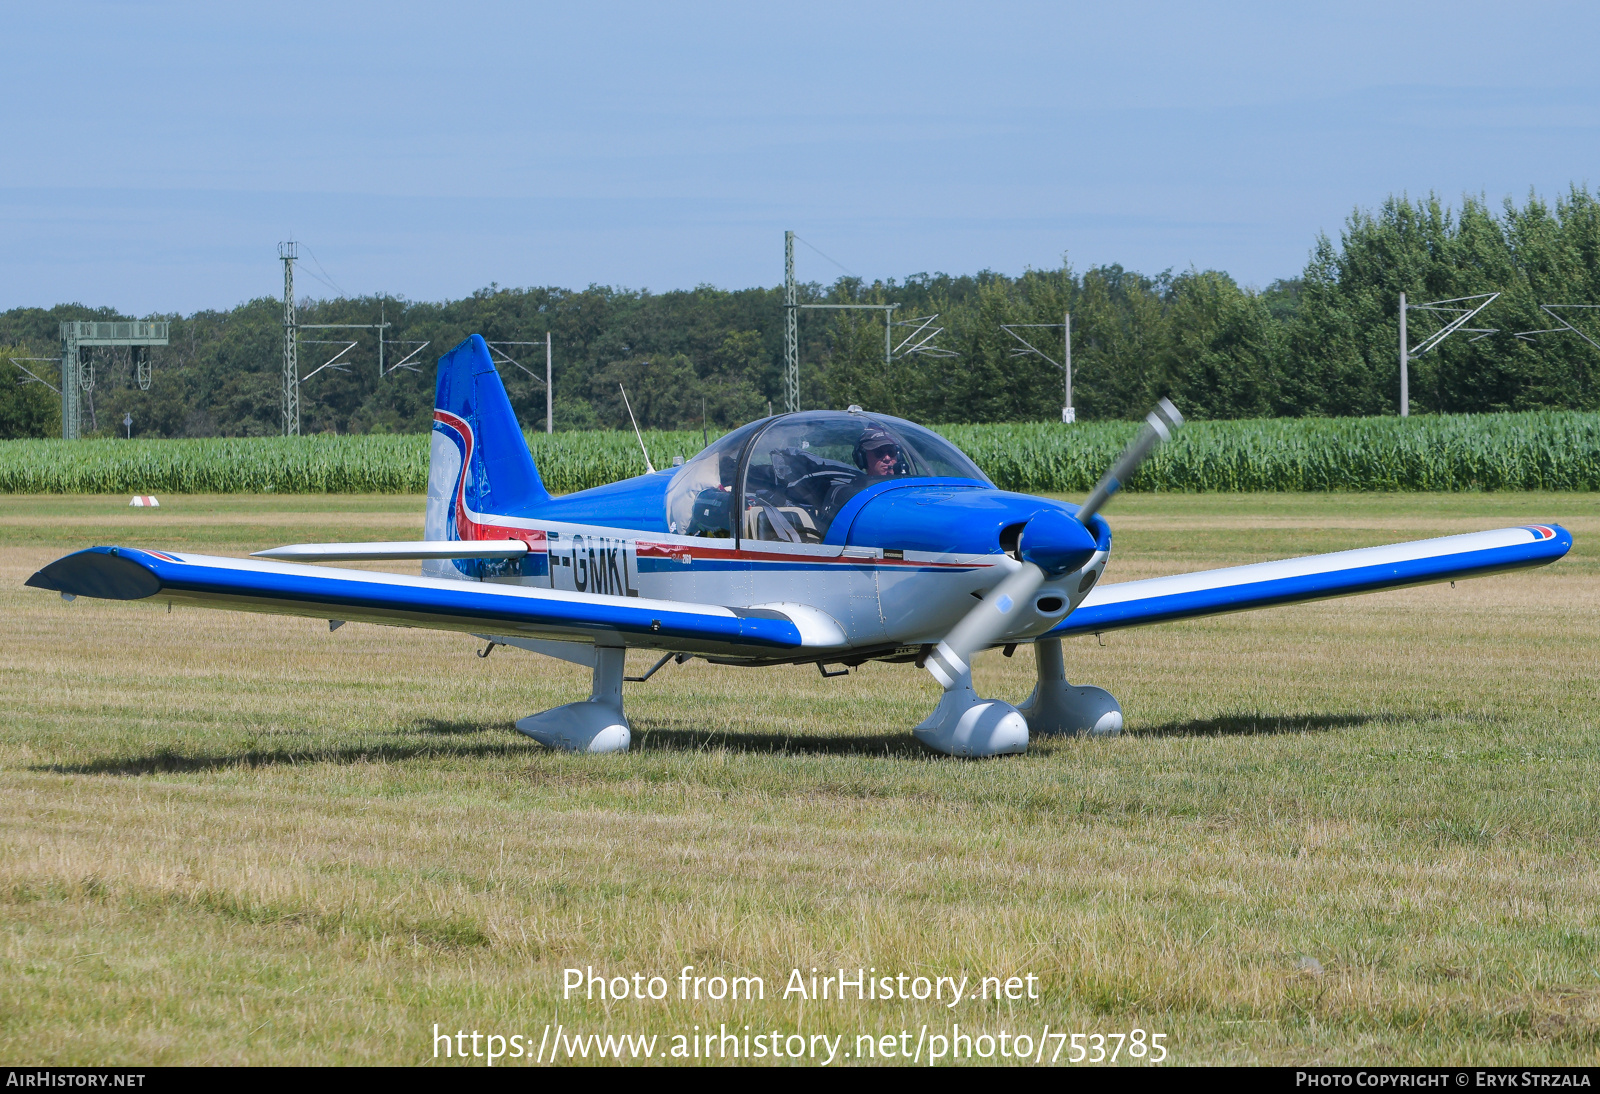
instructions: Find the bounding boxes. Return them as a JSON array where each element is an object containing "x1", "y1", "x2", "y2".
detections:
[{"x1": 0, "y1": 411, "x2": 1600, "y2": 494}]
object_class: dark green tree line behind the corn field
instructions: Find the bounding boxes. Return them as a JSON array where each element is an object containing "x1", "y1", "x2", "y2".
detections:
[{"x1": 0, "y1": 187, "x2": 1600, "y2": 437}]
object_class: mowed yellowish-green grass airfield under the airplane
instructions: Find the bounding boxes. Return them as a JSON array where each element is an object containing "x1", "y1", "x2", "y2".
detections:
[{"x1": 0, "y1": 494, "x2": 1600, "y2": 1064}]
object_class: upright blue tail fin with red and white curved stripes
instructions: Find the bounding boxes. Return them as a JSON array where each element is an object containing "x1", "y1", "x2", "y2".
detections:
[{"x1": 424, "y1": 334, "x2": 550, "y2": 562}]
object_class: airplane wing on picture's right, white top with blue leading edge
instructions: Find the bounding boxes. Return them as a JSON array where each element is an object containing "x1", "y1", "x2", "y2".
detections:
[{"x1": 1045, "y1": 525, "x2": 1573, "y2": 638}]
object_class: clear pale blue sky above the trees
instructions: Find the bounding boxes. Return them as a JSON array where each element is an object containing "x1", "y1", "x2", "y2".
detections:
[{"x1": 0, "y1": 2, "x2": 1600, "y2": 313}]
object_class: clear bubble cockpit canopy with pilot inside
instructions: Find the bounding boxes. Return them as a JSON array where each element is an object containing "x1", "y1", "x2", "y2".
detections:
[{"x1": 667, "y1": 411, "x2": 994, "y2": 544}]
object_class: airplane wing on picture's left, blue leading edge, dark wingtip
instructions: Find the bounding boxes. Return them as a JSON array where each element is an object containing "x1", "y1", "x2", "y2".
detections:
[{"x1": 27, "y1": 547, "x2": 848, "y2": 657}]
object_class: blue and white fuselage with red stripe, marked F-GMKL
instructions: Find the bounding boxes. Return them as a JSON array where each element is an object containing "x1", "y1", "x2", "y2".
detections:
[{"x1": 424, "y1": 419, "x2": 1110, "y2": 664}]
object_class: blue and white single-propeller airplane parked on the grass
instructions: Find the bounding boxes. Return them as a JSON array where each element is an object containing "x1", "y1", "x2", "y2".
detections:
[{"x1": 27, "y1": 334, "x2": 1573, "y2": 757}]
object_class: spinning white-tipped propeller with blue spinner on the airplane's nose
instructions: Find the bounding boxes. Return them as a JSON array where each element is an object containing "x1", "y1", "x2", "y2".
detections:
[{"x1": 925, "y1": 398, "x2": 1184, "y2": 691}]
